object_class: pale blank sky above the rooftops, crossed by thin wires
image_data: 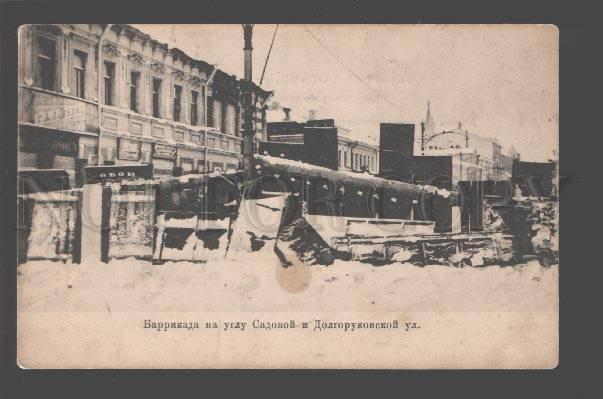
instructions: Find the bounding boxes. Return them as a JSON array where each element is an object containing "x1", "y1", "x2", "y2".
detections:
[{"x1": 134, "y1": 25, "x2": 558, "y2": 161}]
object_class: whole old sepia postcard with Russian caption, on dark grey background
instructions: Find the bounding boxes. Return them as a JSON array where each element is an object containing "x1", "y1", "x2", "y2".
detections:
[{"x1": 16, "y1": 24, "x2": 559, "y2": 369}]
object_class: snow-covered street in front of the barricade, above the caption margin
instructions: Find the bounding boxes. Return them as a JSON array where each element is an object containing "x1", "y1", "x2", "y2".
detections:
[{"x1": 18, "y1": 248, "x2": 559, "y2": 312}]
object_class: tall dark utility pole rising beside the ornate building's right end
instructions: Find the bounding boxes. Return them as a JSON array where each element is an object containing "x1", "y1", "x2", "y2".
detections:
[{"x1": 243, "y1": 24, "x2": 255, "y2": 182}]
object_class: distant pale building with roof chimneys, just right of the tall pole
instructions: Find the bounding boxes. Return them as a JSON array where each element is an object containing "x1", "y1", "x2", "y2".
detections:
[{"x1": 266, "y1": 108, "x2": 379, "y2": 174}]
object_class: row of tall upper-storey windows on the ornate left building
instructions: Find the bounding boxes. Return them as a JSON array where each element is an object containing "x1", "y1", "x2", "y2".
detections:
[{"x1": 37, "y1": 36, "x2": 239, "y2": 135}]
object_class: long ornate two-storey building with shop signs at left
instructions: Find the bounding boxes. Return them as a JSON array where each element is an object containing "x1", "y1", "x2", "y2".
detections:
[{"x1": 18, "y1": 24, "x2": 272, "y2": 184}]
